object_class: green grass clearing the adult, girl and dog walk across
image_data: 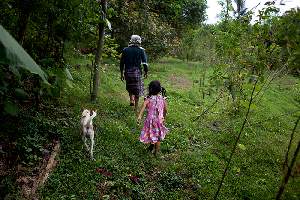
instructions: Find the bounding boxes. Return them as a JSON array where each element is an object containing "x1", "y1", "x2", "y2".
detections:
[{"x1": 40, "y1": 58, "x2": 300, "y2": 199}]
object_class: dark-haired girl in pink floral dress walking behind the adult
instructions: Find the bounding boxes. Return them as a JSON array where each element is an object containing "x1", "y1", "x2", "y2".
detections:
[{"x1": 138, "y1": 81, "x2": 169, "y2": 155}]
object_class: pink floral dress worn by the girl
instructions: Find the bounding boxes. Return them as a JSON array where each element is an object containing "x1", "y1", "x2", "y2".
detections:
[{"x1": 140, "y1": 95, "x2": 169, "y2": 144}]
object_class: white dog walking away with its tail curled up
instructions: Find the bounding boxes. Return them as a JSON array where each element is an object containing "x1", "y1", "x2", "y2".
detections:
[{"x1": 80, "y1": 109, "x2": 97, "y2": 159}]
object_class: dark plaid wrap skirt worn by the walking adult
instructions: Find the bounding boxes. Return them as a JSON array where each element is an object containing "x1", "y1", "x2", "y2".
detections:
[{"x1": 125, "y1": 68, "x2": 144, "y2": 96}]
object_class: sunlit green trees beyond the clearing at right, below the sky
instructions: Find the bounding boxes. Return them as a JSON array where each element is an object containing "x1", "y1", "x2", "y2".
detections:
[{"x1": 178, "y1": 1, "x2": 300, "y2": 74}]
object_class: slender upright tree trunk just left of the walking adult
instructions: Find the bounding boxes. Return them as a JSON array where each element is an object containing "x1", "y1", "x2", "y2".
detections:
[{"x1": 91, "y1": 0, "x2": 107, "y2": 102}]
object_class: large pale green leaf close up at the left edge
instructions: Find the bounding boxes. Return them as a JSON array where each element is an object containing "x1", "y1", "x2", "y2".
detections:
[{"x1": 0, "y1": 25, "x2": 48, "y2": 83}]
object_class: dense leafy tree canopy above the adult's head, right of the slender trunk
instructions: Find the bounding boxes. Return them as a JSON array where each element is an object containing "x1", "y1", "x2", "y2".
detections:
[{"x1": 109, "y1": 0, "x2": 206, "y2": 59}]
